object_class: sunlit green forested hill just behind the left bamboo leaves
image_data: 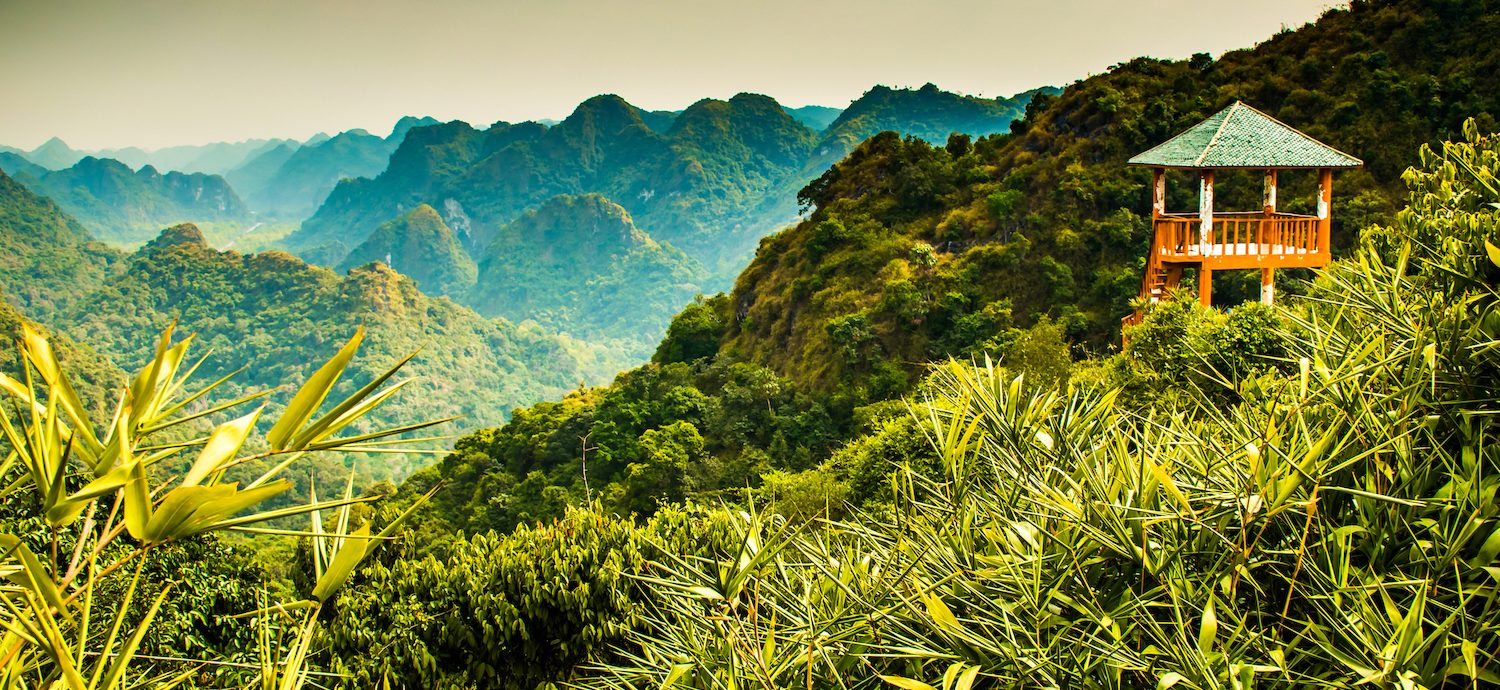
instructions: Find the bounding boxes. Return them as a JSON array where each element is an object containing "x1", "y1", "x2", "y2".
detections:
[{"x1": 47, "y1": 225, "x2": 588, "y2": 447}]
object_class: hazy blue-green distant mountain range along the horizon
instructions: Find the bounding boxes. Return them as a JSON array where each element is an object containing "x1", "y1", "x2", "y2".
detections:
[{"x1": 0, "y1": 84, "x2": 1056, "y2": 357}]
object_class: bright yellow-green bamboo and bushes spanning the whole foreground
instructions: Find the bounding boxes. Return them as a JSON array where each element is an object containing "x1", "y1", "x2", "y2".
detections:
[{"x1": 0, "y1": 113, "x2": 1500, "y2": 690}]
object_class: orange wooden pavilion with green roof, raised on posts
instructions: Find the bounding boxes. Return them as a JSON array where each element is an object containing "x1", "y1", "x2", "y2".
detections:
[{"x1": 1125, "y1": 101, "x2": 1364, "y2": 324}]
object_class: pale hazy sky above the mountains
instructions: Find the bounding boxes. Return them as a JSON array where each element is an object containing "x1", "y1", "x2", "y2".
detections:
[{"x1": 0, "y1": 0, "x2": 1332, "y2": 149}]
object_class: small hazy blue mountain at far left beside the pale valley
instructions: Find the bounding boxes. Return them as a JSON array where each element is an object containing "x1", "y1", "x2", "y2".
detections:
[{"x1": 8, "y1": 156, "x2": 251, "y2": 246}]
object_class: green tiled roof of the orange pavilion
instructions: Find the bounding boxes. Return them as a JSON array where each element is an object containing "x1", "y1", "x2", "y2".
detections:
[{"x1": 1130, "y1": 101, "x2": 1364, "y2": 168}]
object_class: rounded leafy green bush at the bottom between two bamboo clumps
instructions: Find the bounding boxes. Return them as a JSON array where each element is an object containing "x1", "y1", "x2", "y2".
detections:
[{"x1": 323, "y1": 510, "x2": 644, "y2": 690}]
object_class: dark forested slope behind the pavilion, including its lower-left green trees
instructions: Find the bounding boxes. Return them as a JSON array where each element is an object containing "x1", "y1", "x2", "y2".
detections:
[{"x1": 399, "y1": 0, "x2": 1500, "y2": 540}]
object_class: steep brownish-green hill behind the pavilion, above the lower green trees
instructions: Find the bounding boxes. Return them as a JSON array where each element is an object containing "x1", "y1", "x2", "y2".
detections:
[{"x1": 723, "y1": 2, "x2": 1500, "y2": 390}]
